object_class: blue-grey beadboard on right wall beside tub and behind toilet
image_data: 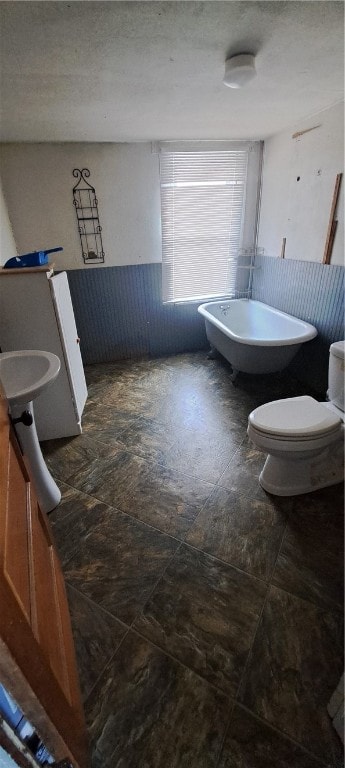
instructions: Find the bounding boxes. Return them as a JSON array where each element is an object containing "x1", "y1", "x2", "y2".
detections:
[{"x1": 252, "y1": 256, "x2": 345, "y2": 395}]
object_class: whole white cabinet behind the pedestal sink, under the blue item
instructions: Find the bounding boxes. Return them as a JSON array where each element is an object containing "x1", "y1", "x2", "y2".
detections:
[{"x1": 0, "y1": 269, "x2": 87, "y2": 440}]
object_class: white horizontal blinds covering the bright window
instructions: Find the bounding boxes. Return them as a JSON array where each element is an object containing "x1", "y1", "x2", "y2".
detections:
[{"x1": 160, "y1": 149, "x2": 248, "y2": 302}]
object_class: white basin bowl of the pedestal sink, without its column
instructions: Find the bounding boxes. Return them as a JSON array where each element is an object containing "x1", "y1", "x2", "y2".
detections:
[{"x1": 0, "y1": 349, "x2": 60, "y2": 405}]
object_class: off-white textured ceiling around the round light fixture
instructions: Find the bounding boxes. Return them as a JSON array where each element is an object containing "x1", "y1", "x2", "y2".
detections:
[{"x1": 0, "y1": 0, "x2": 344, "y2": 142}]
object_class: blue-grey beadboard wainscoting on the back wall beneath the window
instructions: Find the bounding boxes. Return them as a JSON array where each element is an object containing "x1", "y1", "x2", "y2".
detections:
[{"x1": 68, "y1": 264, "x2": 208, "y2": 364}]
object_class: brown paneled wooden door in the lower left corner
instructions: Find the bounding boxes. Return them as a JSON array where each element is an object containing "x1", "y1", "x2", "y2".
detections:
[{"x1": 0, "y1": 392, "x2": 88, "y2": 768}]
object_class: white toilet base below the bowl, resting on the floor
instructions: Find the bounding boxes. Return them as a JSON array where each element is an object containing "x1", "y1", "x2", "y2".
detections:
[{"x1": 259, "y1": 440, "x2": 344, "y2": 496}]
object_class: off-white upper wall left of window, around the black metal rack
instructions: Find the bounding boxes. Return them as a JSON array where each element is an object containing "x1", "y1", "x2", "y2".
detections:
[{"x1": 1, "y1": 144, "x2": 161, "y2": 270}]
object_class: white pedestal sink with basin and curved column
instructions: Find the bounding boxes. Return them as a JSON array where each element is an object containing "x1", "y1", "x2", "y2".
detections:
[{"x1": 0, "y1": 349, "x2": 61, "y2": 512}]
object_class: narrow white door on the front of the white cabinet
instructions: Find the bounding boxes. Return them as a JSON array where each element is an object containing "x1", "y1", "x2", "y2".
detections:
[{"x1": 49, "y1": 272, "x2": 87, "y2": 421}]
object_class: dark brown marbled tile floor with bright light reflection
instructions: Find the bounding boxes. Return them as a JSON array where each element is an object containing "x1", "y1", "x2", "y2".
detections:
[{"x1": 43, "y1": 353, "x2": 344, "y2": 768}]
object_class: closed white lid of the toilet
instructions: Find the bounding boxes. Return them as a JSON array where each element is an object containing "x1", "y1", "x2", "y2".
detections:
[{"x1": 249, "y1": 395, "x2": 341, "y2": 438}]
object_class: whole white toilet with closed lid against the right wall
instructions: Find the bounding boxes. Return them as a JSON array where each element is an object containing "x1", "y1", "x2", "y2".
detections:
[{"x1": 248, "y1": 341, "x2": 345, "y2": 496}]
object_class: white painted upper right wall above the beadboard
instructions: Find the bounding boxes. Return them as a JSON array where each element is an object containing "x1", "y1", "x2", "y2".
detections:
[{"x1": 258, "y1": 104, "x2": 345, "y2": 264}]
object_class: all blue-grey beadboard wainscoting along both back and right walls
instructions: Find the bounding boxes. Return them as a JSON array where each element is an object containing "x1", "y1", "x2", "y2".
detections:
[{"x1": 68, "y1": 256, "x2": 345, "y2": 396}]
